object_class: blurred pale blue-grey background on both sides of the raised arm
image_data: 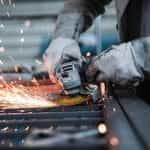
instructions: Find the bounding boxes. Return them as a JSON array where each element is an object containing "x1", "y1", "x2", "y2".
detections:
[{"x1": 0, "y1": 0, "x2": 119, "y2": 68}]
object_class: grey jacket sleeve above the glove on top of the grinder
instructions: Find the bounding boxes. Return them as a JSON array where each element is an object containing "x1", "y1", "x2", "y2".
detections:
[{"x1": 53, "y1": 0, "x2": 112, "y2": 40}]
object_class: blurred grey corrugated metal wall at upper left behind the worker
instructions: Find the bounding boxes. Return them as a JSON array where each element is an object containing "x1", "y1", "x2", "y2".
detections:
[{"x1": 0, "y1": 0, "x2": 115, "y2": 67}]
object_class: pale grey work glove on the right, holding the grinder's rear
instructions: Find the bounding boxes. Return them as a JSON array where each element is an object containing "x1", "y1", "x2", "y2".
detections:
[{"x1": 86, "y1": 42, "x2": 143, "y2": 86}]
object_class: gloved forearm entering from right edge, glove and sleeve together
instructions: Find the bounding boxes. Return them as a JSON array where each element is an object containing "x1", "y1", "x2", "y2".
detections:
[{"x1": 87, "y1": 37, "x2": 150, "y2": 86}]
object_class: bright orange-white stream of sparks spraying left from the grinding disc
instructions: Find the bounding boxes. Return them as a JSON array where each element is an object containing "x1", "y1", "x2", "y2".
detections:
[{"x1": 0, "y1": 81, "x2": 56, "y2": 109}]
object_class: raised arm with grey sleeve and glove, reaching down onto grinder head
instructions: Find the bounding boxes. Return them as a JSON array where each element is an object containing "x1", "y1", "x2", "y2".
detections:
[{"x1": 44, "y1": 0, "x2": 111, "y2": 74}]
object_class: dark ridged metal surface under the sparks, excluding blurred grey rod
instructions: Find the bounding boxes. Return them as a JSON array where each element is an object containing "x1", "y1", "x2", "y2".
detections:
[{"x1": 0, "y1": 104, "x2": 108, "y2": 149}]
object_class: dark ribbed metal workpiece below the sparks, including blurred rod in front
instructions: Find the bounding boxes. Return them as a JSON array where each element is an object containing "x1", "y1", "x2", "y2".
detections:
[{"x1": 0, "y1": 99, "x2": 108, "y2": 150}]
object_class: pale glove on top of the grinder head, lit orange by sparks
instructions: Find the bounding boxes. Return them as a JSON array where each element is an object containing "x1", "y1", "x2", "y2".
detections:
[{"x1": 43, "y1": 37, "x2": 82, "y2": 75}]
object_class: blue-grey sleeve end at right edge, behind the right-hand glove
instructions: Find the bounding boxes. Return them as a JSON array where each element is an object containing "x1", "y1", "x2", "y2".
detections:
[{"x1": 131, "y1": 37, "x2": 150, "y2": 78}]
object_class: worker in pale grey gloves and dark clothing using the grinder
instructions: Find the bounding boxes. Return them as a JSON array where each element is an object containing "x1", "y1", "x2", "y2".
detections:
[{"x1": 44, "y1": 0, "x2": 150, "y2": 86}]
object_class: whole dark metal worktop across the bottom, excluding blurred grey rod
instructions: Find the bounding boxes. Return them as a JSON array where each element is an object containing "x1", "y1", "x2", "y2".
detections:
[{"x1": 0, "y1": 87, "x2": 150, "y2": 150}]
